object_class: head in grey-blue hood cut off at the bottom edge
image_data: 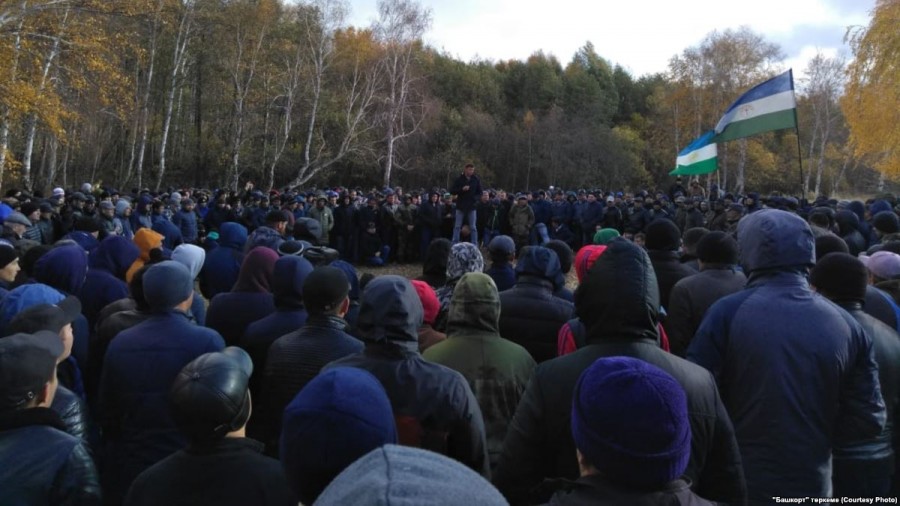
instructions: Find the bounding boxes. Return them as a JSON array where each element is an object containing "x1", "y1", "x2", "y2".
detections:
[{"x1": 316, "y1": 444, "x2": 508, "y2": 506}]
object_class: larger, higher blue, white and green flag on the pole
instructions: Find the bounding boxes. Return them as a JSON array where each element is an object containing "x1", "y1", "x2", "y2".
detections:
[{"x1": 716, "y1": 70, "x2": 797, "y2": 142}]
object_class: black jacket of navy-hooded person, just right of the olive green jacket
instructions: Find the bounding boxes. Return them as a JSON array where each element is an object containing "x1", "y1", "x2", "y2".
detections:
[{"x1": 500, "y1": 274, "x2": 575, "y2": 363}]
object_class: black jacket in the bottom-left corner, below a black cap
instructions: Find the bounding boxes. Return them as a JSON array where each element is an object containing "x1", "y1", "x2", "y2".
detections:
[{"x1": 0, "y1": 408, "x2": 101, "y2": 506}]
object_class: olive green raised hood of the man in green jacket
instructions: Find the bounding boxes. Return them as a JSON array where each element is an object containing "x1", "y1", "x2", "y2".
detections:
[{"x1": 447, "y1": 272, "x2": 500, "y2": 335}]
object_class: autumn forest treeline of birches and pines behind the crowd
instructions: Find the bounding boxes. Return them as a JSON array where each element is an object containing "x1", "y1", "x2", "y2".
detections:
[{"x1": 0, "y1": 0, "x2": 900, "y2": 194}]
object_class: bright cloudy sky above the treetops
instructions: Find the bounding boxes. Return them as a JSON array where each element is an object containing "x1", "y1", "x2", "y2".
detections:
[{"x1": 349, "y1": 0, "x2": 875, "y2": 77}]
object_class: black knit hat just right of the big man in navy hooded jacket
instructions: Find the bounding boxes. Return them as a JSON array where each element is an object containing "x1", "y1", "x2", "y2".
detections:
[{"x1": 809, "y1": 253, "x2": 869, "y2": 302}]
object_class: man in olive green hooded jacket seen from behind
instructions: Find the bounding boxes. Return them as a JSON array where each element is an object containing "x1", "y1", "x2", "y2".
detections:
[{"x1": 423, "y1": 272, "x2": 535, "y2": 468}]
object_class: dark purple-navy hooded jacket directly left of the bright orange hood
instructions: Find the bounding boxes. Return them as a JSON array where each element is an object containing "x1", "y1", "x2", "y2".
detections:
[{"x1": 78, "y1": 236, "x2": 140, "y2": 329}]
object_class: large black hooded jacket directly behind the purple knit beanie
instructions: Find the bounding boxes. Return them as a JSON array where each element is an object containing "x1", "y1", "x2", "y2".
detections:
[{"x1": 494, "y1": 239, "x2": 746, "y2": 505}]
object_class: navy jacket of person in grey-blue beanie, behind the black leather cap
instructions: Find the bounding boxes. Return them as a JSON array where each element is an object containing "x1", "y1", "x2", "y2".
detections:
[{"x1": 100, "y1": 310, "x2": 225, "y2": 501}]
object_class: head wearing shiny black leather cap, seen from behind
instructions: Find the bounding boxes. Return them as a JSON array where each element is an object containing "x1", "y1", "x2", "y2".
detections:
[{"x1": 169, "y1": 346, "x2": 253, "y2": 446}]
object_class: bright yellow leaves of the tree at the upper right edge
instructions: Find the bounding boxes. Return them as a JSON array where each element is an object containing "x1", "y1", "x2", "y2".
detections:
[{"x1": 841, "y1": 0, "x2": 900, "y2": 176}]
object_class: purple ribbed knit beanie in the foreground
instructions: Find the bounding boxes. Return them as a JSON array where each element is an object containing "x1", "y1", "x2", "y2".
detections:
[{"x1": 572, "y1": 357, "x2": 691, "y2": 489}]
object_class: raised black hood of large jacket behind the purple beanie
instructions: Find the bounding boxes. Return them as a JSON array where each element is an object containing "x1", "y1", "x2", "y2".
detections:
[{"x1": 575, "y1": 239, "x2": 660, "y2": 340}]
